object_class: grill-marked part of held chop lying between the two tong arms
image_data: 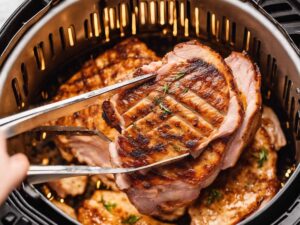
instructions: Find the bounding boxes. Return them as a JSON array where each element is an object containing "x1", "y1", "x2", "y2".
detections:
[{"x1": 103, "y1": 41, "x2": 242, "y2": 167}]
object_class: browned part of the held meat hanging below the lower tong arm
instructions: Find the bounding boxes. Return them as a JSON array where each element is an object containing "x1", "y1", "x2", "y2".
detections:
[{"x1": 116, "y1": 140, "x2": 227, "y2": 221}]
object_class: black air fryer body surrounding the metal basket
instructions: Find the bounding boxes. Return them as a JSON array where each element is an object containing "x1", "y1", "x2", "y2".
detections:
[{"x1": 0, "y1": 0, "x2": 300, "y2": 225}]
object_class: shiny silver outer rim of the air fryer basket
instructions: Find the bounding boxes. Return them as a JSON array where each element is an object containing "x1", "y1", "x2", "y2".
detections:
[{"x1": 0, "y1": 0, "x2": 300, "y2": 224}]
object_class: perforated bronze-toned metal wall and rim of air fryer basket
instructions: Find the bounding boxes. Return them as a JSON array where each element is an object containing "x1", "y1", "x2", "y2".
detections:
[{"x1": 0, "y1": 0, "x2": 300, "y2": 224}]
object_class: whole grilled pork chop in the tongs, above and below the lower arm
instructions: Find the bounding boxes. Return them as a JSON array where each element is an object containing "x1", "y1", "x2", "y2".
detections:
[{"x1": 103, "y1": 42, "x2": 241, "y2": 220}]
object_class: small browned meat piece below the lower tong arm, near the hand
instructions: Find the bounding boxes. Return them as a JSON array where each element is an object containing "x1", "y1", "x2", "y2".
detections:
[{"x1": 48, "y1": 176, "x2": 87, "y2": 198}]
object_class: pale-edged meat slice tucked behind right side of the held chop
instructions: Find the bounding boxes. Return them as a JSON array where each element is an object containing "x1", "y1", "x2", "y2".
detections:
[{"x1": 222, "y1": 52, "x2": 262, "y2": 169}]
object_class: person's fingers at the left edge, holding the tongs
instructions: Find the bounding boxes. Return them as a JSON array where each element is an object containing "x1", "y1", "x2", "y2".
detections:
[{"x1": 0, "y1": 133, "x2": 29, "y2": 205}]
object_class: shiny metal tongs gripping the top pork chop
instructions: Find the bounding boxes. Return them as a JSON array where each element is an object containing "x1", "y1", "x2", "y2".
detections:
[{"x1": 0, "y1": 73, "x2": 189, "y2": 184}]
